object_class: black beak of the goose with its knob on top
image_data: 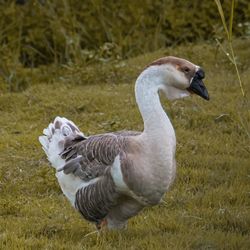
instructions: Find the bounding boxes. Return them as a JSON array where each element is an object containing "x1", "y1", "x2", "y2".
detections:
[{"x1": 187, "y1": 68, "x2": 209, "y2": 100}]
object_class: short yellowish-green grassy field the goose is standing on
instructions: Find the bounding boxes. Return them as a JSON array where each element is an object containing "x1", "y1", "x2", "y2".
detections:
[{"x1": 0, "y1": 40, "x2": 250, "y2": 250}]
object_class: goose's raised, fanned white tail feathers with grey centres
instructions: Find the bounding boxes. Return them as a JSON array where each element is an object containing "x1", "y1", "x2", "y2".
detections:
[{"x1": 39, "y1": 116, "x2": 85, "y2": 169}]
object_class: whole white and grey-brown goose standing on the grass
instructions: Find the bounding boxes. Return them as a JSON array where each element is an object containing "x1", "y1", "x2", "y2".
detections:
[{"x1": 39, "y1": 56, "x2": 209, "y2": 229}]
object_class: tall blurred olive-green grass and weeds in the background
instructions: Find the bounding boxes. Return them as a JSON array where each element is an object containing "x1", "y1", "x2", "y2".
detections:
[{"x1": 0, "y1": 0, "x2": 250, "y2": 66}]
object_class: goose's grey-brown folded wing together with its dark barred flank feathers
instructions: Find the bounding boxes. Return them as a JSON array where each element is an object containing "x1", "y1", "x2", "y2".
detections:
[{"x1": 59, "y1": 131, "x2": 140, "y2": 226}]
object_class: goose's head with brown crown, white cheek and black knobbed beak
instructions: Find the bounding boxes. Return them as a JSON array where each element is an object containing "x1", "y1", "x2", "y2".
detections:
[{"x1": 146, "y1": 56, "x2": 209, "y2": 100}]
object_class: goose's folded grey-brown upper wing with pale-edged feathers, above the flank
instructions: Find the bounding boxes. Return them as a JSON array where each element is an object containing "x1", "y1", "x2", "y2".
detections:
[{"x1": 59, "y1": 131, "x2": 140, "y2": 181}]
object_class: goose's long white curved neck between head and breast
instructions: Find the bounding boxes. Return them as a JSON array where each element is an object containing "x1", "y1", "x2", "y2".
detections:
[{"x1": 135, "y1": 70, "x2": 175, "y2": 141}]
